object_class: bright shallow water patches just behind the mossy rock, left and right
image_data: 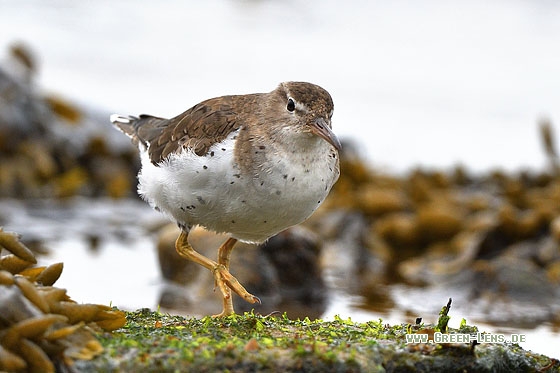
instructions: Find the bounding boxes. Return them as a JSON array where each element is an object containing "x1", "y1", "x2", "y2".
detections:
[{"x1": 0, "y1": 198, "x2": 560, "y2": 358}]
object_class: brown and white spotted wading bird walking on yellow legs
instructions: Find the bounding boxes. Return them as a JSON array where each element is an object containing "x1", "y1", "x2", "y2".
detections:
[{"x1": 110, "y1": 82, "x2": 341, "y2": 317}]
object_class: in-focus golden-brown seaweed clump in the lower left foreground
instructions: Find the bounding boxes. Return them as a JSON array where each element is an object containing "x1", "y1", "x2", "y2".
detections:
[{"x1": 0, "y1": 228, "x2": 126, "y2": 372}]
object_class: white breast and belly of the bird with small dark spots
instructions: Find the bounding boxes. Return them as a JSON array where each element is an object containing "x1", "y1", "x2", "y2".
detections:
[{"x1": 138, "y1": 132, "x2": 338, "y2": 242}]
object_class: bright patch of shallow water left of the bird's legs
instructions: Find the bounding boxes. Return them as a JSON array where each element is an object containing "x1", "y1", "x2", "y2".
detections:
[{"x1": 0, "y1": 198, "x2": 167, "y2": 310}]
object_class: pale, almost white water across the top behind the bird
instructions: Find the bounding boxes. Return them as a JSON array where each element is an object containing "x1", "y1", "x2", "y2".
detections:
[{"x1": 0, "y1": 0, "x2": 560, "y2": 171}]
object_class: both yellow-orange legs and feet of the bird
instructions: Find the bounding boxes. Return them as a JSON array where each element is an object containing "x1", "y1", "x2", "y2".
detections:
[{"x1": 175, "y1": 231, "x2": 260, "y2": 316}]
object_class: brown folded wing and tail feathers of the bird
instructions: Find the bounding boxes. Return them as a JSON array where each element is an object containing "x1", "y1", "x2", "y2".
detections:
[{"x1": 113, "y1": 96, "x2": 241, "y2": 165}]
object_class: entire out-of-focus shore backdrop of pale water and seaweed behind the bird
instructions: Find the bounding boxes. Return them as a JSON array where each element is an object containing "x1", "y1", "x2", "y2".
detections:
[{"x1": 0, "y1": 0, "x2": 560, "y2": 357}]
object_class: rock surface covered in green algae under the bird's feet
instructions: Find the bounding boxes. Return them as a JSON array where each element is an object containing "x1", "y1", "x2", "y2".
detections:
[{"x1": 76, "y1": 309, "x2": 560, "y2": 372}]
